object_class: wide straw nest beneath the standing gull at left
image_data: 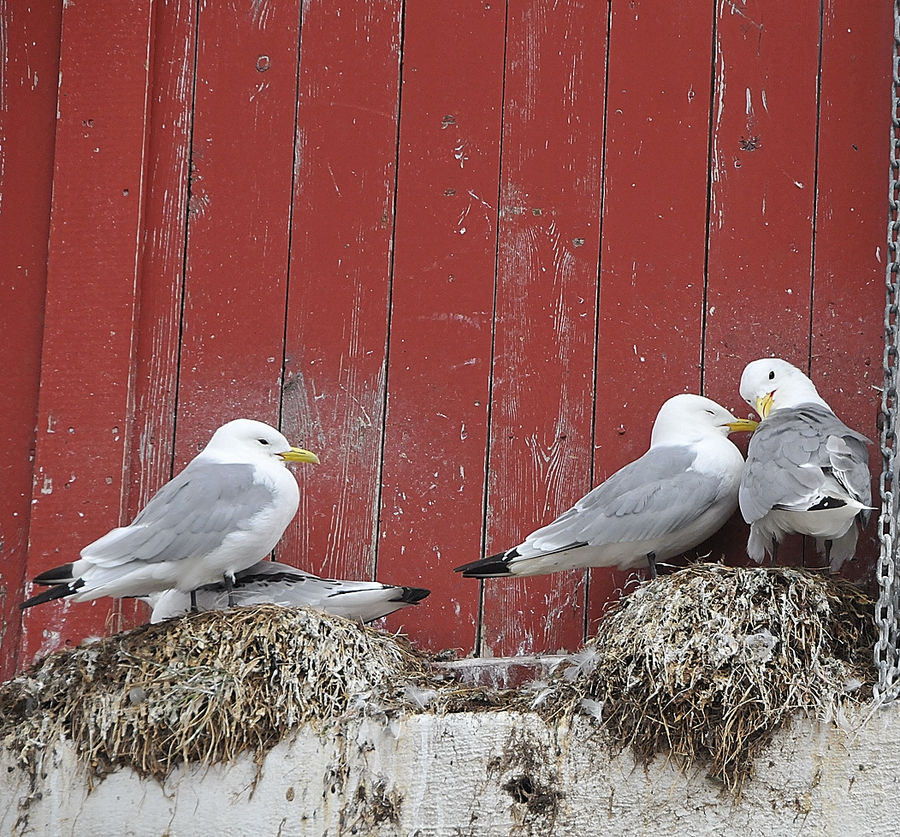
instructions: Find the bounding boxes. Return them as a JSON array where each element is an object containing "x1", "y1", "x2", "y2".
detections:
[{"x1": 0, "y1": 605, "x2": 510, "y2": 779}]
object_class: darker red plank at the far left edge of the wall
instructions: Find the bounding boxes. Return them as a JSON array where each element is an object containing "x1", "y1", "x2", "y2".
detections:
[{"x1": 0, "y1": 0, "x2": 62, "y2": 680}]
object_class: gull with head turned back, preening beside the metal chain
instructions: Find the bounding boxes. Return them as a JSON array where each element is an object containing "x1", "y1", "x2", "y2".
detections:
[{"x1": 740, "y1": 358, "x2": 872, "y2": 572}]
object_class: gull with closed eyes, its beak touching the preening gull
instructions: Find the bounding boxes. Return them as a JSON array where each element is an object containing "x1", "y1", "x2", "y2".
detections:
[{"x1": 456, "y1": 394, "x2": 756, "y2": 578}]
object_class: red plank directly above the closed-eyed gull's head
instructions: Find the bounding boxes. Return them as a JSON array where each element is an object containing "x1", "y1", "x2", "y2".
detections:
[{"x1": 589, "y1": 0, "x2": 713, "y2": 622}]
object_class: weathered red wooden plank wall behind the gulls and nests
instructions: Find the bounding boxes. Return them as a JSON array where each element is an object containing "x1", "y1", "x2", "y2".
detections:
[{"x1": 0, "y1": 0, "x2": 892, "y2": 674}]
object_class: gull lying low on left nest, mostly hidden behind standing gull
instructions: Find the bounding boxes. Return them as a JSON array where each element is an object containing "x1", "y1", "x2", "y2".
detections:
[{"x1": 144, "y1": 561, "x2": 431, "y2": 623}]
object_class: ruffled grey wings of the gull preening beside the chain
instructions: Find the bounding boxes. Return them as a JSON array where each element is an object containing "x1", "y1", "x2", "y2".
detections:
[{"x1": 739, "y1": 404, "x2": 872, "y2": 523}]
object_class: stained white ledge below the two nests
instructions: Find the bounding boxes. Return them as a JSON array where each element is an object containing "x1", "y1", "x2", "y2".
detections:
[{"x1": 0, "y1": 707, "x2": 900, "y2": 837}]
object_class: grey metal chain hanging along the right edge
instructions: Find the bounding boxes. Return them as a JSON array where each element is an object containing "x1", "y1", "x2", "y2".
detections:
[{"x1": 874, "y1": 0, "x2": 900, "y2": 703}]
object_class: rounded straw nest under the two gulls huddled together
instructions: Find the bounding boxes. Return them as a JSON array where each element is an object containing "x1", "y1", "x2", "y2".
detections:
[{"x1": 545, "y1": 564, "x2": 875, "y2": 793}]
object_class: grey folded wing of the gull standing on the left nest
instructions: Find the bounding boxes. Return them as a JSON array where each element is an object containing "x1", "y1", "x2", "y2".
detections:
[{"x1": 81, "y1": 462, "x2": 273, "y2": 567}]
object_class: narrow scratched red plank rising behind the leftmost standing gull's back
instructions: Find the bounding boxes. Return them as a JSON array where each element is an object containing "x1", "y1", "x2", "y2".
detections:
[{"x1": 119, "y1": 0, "x2": 197, "y2": 627}]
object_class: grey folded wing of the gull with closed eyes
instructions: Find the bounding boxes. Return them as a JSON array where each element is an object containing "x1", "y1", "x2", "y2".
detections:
[{"x1": 520, "y1": 446, "x2": 722, "y2": 554}]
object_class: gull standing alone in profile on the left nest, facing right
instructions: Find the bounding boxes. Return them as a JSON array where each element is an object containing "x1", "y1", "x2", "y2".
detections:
[{"x1": 20, "y1": 419, "x2": 319, "y2": 608}]
